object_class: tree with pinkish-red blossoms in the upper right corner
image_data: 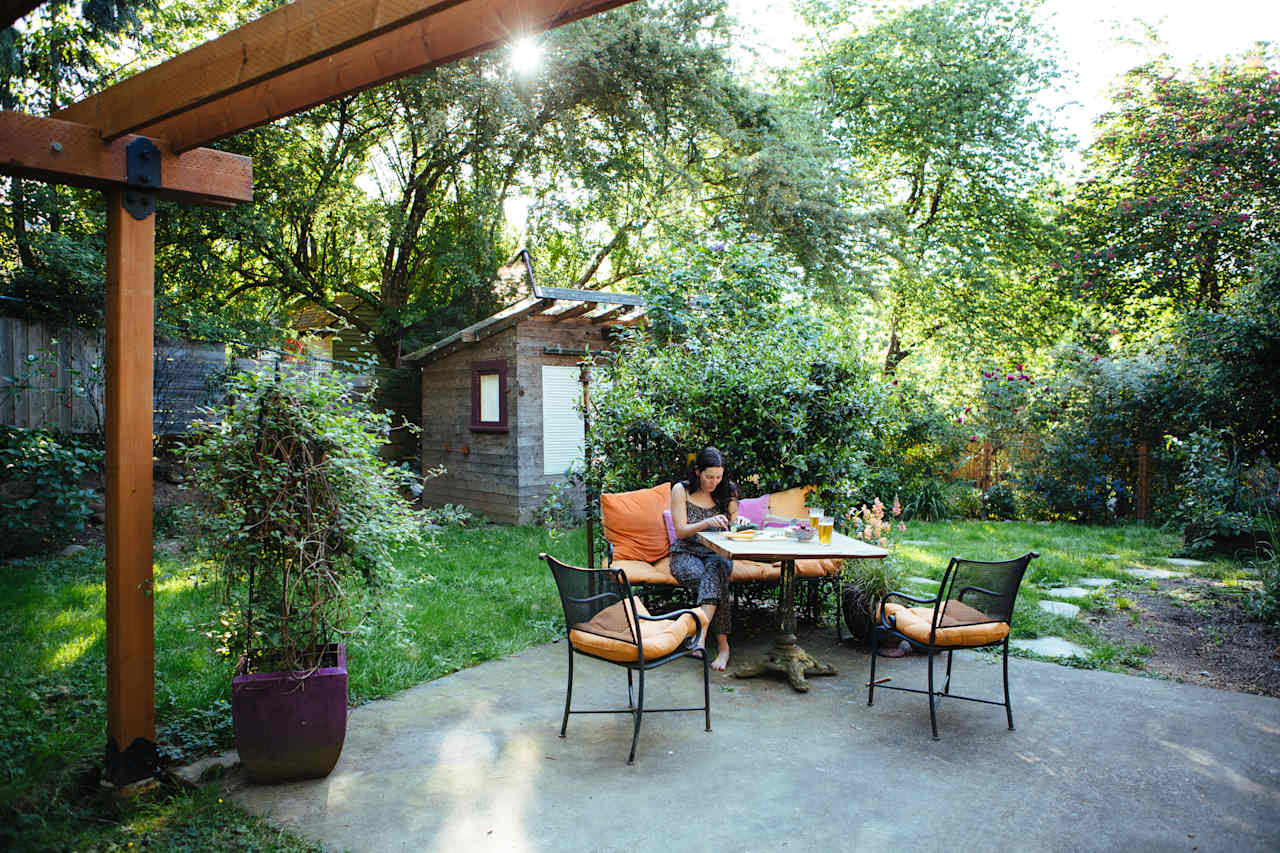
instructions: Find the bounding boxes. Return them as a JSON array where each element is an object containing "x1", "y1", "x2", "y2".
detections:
[{"x1": 1070, "y1": 49, "x2": 1280, "y2": 313}]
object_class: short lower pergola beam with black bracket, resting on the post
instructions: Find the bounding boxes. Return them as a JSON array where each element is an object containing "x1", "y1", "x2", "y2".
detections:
[{"x1": 0, "y1": 110, "x2": 253, "y2": 205}]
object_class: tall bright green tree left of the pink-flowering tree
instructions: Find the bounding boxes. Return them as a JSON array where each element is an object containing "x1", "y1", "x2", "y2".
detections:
[{"x1": 805, "y1": 0, "x2": 1064, "y2": 373}]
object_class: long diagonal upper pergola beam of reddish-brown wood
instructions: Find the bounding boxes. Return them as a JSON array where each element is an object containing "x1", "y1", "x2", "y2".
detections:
[{"x1": 56, "y1": 0, "x2": 627, "y2": 151}]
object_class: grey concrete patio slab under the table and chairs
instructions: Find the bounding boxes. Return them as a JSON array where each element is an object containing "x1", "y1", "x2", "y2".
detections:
[{"x1": 222, "y1": 630, "x2": 1280, "y2": 853}]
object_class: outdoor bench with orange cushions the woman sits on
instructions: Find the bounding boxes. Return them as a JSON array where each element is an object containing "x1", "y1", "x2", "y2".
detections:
[{"x1": 600, "y1": 483, "x2": 844, "y2": 630}]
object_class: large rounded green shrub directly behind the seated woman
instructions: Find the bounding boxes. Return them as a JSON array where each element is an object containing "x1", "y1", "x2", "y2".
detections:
[{"x1": 586, "y1": 239, "x2": 884, "y2": 512}]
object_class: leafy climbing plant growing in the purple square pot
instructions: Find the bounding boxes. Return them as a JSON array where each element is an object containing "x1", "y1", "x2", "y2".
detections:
[{"x1": 187, "y1": 373, "x2": 421, "y2": 672}]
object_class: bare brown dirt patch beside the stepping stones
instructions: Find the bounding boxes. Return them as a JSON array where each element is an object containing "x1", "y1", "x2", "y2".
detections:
[{"x1": 1087, "y1": 578, "x2": 1280, "y2": 697}]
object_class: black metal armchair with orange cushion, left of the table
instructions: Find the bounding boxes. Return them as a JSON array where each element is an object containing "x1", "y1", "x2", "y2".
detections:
[{"x1": 538, "y1": 553, "x2": 712, "y2": 765}]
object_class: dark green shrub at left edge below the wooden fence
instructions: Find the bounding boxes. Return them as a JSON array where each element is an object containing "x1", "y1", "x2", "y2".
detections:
[{"x1": 0, "y1": 427, "x2": 102, "y2": 557}]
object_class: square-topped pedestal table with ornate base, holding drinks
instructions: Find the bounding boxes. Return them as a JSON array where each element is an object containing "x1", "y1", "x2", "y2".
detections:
[{"x1": 698, "y1": 530, "x2": 888, "y2": 693}]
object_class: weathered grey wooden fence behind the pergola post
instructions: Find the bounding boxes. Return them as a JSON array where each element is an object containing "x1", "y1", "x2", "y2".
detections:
[{"x1": 0, "y1": 316, "x2": 227, "y2": 435}]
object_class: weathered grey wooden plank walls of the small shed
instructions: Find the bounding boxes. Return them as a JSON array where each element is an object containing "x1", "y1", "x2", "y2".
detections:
[{"x1": 422, "y1": 315, "x2": 608, "y2": 524}]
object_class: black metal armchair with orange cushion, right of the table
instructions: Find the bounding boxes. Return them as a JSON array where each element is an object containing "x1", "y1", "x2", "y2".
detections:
[{"x1": 867, "y1": 551, "x2": 1039, "y2": 740}]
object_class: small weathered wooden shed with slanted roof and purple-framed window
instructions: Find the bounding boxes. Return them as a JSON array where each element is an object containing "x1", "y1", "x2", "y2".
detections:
[{"x1": 404, "y1": 284, "x2": 645, "y2": 524}]
